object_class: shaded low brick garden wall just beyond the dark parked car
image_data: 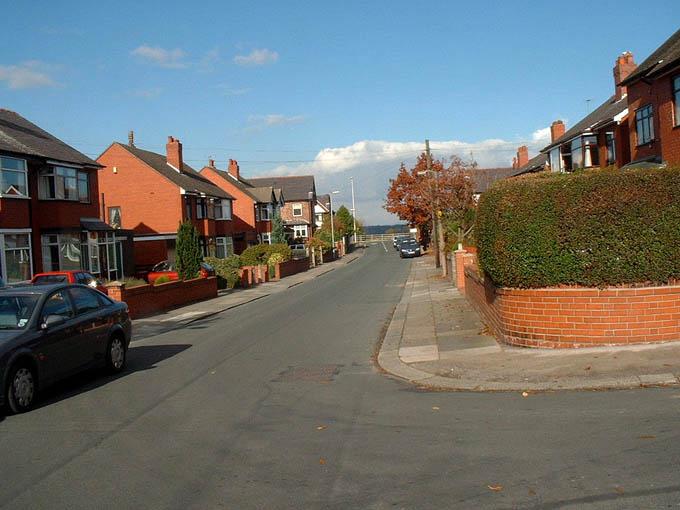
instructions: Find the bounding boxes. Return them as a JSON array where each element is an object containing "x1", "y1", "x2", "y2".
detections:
[{"x1": 107, "y1": 277, "x2": 217, "y2": 319}]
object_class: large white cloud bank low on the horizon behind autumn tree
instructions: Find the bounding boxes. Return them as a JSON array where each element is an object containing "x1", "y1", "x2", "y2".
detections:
[{"x1": 252, "y1": 129, "x2": 549, "y2": 225}]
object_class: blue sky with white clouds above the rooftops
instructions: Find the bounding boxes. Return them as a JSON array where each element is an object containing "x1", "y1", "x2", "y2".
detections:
[{"x1": 0, "y1": 0, "x2": 680, "y2": 224}]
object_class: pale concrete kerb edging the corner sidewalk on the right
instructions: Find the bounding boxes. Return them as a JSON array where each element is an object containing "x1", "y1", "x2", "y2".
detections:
[{"x1": 376, "y1": 260, "x2": 680, "y2": 392}]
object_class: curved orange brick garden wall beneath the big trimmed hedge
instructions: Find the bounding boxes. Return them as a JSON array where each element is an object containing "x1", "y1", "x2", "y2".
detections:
[{"x1": 456, "y1": 253, "x2": 680, "y2": 349}]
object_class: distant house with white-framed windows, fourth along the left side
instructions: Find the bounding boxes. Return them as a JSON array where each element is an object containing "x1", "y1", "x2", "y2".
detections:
[{"x1": 247, "y1": 175, "x2": 316, "y2": 242}]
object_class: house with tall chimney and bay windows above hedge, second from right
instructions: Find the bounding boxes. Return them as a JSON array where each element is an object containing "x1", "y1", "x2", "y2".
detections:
[{"x1": 541, "y1": 52, "x2": 636, "y2": 172}]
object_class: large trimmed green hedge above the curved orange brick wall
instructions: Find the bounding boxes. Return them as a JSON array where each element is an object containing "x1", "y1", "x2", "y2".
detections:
[{"x1": 475, "y1": 168, "x2": 680, "y2": 288}]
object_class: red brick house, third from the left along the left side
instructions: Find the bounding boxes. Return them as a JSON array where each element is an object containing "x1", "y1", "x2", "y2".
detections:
[{"x1": 200, "y1": 159, "x2": 284, "y2": 254}]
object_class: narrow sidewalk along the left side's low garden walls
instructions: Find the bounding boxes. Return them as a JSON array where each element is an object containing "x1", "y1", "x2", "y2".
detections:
[{"x1": 132, "y1": 248, "x2": 364, "y2": 341}]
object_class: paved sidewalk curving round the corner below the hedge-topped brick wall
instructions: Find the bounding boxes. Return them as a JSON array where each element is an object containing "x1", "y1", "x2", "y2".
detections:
[{"x1": 378, "y1": 256, "x2": 680, "y2": 391}]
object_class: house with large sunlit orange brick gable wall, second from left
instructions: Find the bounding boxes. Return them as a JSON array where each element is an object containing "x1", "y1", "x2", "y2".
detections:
[{"x1": 97, "y1": 132, "x2": 234, "y2": 271}]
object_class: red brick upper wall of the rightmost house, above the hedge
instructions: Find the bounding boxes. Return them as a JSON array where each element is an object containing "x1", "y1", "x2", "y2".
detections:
[{"x1": 628, "y1": 70, "x2": 680, "y2": 165}]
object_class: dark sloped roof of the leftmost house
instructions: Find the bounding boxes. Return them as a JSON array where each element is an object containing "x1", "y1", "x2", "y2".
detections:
[{"x1": 0, "y1": 108, "x2": 101, "y2": 167}]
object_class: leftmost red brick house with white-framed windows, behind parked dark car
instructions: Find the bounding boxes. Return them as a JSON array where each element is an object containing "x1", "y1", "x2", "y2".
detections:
[{"x1": 0, "y1": 109, "x2": 124, "y2": 283}]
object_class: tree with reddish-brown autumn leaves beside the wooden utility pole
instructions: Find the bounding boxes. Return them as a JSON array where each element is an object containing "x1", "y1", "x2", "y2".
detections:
[{"x1": 384, "y1": 153, "x2": 477, "y2": 252}]
